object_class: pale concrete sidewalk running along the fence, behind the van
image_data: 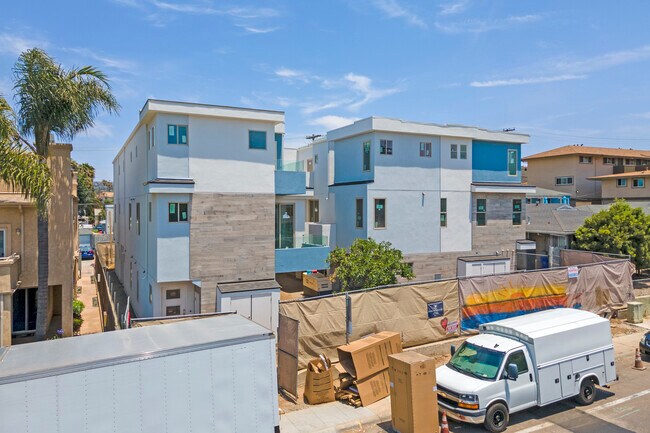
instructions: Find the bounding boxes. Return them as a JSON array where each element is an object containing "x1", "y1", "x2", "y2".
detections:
[{"x1": 280, "y1": 318, "x2": 650, "y2": 433}]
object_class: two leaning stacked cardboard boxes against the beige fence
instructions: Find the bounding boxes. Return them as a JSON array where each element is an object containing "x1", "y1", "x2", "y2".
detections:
[{"x1": 337, "y1": 331, "x2": 402, "y2": 406}]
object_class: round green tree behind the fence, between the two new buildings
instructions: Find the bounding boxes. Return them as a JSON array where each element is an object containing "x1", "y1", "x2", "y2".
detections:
[{"x1": 327, "y1": 239, "x2": 414, "y2": 290}]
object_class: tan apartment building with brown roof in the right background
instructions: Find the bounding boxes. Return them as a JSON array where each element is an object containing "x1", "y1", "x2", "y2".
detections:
[{"x1": 523, "y1": 145, "x2": 650, "y2": 203}]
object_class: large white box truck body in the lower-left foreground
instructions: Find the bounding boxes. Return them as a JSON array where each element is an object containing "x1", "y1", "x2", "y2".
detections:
[{"x1": 0, "y1": 314, "x2": 280, "y2": 433}]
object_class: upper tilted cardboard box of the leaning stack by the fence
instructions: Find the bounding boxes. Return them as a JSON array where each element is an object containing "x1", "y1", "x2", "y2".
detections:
[{"x1": 338, "y1": 331, "x2": 402, "y2": 380}]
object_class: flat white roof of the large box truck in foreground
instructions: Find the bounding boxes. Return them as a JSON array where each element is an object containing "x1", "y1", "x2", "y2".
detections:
[{"x1": 0, "y1": 314, "x2": 273, "y2": 384}]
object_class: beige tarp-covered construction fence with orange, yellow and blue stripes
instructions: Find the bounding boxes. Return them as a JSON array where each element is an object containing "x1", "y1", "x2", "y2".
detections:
[{"x1": 278, "y1": 251, "x2": 634, "y2": 369}]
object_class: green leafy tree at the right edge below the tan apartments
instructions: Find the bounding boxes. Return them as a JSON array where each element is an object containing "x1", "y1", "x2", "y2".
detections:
[{"x1": 574, "y1": 200, "x2": 650, "y2": 272}]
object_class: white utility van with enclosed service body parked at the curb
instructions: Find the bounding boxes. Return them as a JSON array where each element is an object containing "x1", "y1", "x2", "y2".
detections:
[{"x1": 436, "y1": 308, "x2": 617, "y2": 432}]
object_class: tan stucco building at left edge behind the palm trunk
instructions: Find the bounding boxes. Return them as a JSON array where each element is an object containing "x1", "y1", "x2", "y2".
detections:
[{"x1": 0, "y1": 144, "x2": 79, "y2": 346}]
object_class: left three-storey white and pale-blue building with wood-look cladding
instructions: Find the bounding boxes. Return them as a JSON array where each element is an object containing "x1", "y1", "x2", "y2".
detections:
[{"x1": 113, "y1": 100, "x2": 286, "y2": 329}]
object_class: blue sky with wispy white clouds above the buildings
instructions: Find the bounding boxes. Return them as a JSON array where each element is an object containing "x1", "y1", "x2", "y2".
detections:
[{"x1": 0, "y1": 0, "x2": 650, "y2": 179}]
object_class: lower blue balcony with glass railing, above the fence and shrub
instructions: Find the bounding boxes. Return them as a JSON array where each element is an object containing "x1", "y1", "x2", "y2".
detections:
[{"x1": 275, "y1": 234, "x2": 330, "y2": 274}]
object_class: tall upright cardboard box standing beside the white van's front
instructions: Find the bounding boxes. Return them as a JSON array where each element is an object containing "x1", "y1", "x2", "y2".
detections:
[{"x1": 388, "y1": 352, "x2": 438, "y2": 433}]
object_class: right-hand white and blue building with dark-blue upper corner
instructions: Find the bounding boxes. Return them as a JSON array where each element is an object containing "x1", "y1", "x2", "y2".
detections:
[{"x1": 293, "y1": 117, "x2": 535, "y2": 280}]
